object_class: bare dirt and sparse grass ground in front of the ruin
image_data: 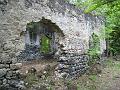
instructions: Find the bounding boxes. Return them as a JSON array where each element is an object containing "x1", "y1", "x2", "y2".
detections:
[{"x1": 20, "y1": 58, "x2": 120, "y2": 90}]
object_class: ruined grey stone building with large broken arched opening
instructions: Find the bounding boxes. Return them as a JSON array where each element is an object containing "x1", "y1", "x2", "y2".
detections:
[{"x1": 0, "y1": 0, "x2": 106, "y2": 77}]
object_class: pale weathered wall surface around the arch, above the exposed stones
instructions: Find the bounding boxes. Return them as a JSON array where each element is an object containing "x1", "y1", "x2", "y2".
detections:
[{"x1": 0, "y1": 0, "x2": 105, "y2": 60}]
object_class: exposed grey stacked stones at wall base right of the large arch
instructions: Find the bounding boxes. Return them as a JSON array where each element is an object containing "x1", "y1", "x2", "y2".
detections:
[{"x1": 56, "y1": 51, "x2": 88, "y2": 78}]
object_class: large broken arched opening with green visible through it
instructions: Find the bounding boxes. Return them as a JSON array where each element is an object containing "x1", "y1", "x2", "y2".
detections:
[{"x1": 17, "y1": 18, "x2": 64, "y2": 60}]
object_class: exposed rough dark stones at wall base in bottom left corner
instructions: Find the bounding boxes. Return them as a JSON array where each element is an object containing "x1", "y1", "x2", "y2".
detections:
[{"x1": 0, "y1": 60, "x2": 25, "y2": 90}]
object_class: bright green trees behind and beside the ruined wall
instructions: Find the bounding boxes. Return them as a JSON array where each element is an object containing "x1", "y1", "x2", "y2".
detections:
[{"x1": 68, "y1": 0, "x2": 120, "y2": 55}]
